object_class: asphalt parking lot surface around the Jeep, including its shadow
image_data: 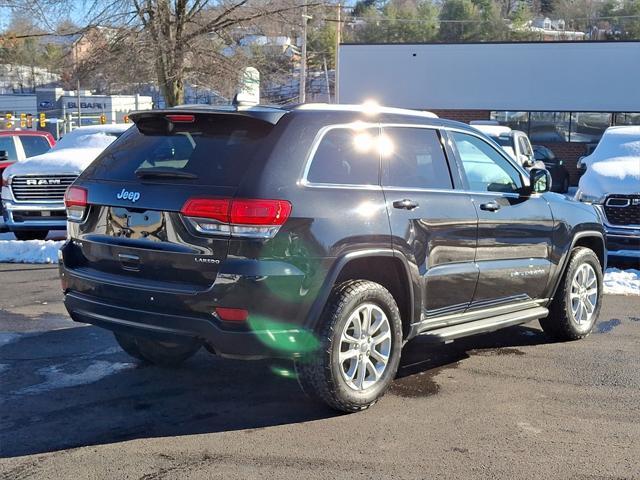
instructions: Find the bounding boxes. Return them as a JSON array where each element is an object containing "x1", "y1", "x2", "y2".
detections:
[{"x1": 0, "y1": 264, "x2": 640, "y2": 480}]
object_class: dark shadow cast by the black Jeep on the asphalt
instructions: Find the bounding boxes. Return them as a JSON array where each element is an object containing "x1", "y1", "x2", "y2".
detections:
[{"x1": 0, "y1": 318, "x2": 547, "y2": 457}]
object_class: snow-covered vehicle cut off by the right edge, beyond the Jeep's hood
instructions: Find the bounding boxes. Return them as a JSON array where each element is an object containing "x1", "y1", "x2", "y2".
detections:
[{"x1": 576, "y1": 126, "x2": 640, "y2": 258}]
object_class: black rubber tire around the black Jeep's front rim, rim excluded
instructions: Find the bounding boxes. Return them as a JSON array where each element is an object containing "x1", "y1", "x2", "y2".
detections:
[{"x1": 540, "y1": 247, "x2": 603, "y2": 341}]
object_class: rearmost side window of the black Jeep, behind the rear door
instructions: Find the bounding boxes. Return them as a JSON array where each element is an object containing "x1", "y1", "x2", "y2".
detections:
[{"x1": 307, "y1": 128, "x2": 380, "y2": 185}]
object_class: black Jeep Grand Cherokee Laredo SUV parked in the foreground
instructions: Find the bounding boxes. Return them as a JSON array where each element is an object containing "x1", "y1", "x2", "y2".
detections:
[{"x1": 60, "y1": 105, "x2": 606, "y2": 411}]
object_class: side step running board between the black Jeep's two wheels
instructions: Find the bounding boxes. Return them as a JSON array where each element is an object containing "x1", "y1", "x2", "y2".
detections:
[{"x1": 418, "y1": 307, "x2": 549, "y2": 343}]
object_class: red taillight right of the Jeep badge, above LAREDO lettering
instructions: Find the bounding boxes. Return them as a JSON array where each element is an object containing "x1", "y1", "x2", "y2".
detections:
[{"x1": 181, "y1": 198, "x2": 291, "y2": 238}]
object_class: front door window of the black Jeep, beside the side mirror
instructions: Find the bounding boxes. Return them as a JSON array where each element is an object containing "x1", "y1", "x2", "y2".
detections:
[{"x1": 451, "y1": 132, "x2": 522, "y2": 193}]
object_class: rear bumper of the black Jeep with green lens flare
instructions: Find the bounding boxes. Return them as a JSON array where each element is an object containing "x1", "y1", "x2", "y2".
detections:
[{"x1": 60, "y1": 251, "x2": 318, "y2": 359}]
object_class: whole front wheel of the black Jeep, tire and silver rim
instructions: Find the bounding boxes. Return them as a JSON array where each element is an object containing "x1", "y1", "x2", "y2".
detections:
[{"x1": 540, "y1": 247, "x2": 603, "y2": 341}]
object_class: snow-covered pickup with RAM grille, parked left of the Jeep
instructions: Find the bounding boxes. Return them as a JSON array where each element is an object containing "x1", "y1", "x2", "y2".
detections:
[{"x1": 2, "y1": 125, "x2": 130, "y2": 240}]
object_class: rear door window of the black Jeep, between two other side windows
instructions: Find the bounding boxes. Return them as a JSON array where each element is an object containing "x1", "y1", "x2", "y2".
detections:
[{"x1": 382, "y1": 127, "x2": 453, "y2": 189}]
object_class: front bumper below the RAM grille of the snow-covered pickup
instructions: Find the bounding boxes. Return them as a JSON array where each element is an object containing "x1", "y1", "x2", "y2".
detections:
[{"x1": 2, "y1": 200, "x2": 67, "y2": 231}]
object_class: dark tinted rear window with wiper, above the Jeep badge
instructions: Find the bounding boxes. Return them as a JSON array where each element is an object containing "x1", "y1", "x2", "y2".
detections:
[{"x1": 87, "y1": 115, "x2": 273, "y2": 186}]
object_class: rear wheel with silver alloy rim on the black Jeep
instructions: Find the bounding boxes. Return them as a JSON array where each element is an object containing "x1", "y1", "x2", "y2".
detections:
[{"x1": 296, "y1": 280, "x2": 402, "y2": 412}]
